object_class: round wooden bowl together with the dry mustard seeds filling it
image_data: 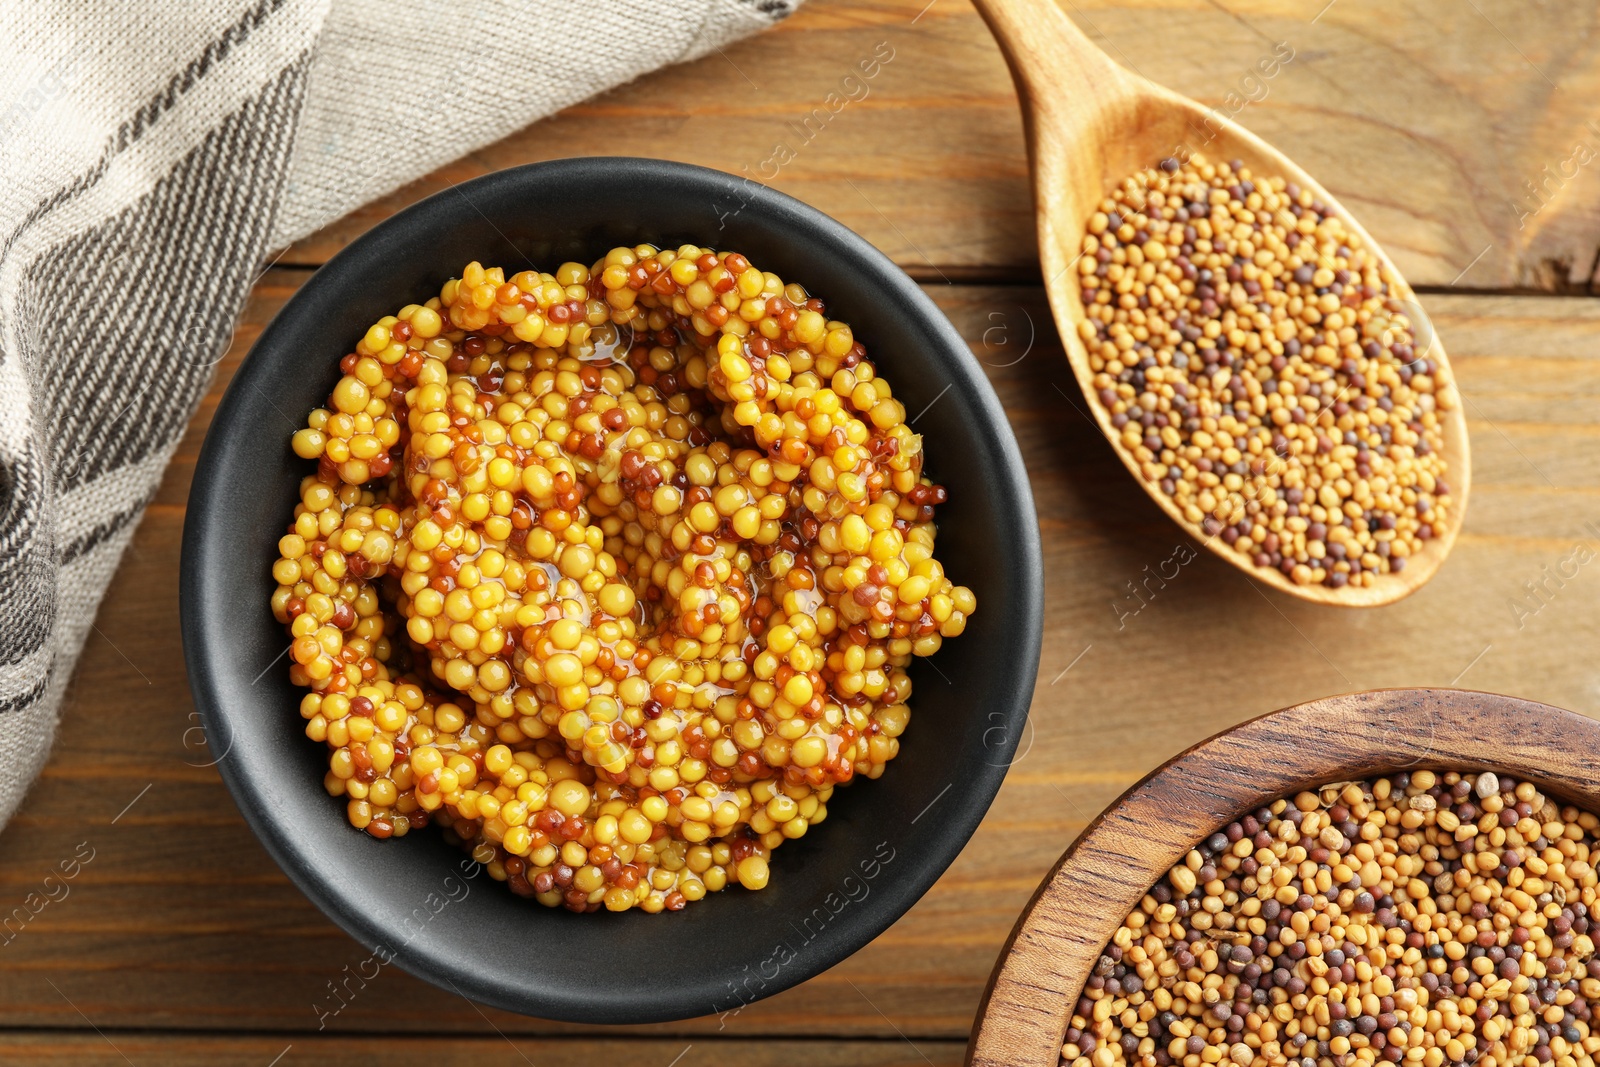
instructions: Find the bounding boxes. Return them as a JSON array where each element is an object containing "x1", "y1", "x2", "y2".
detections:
[{"x1": 971, "y1": 689, "x2": 1600, "y2": 1067}]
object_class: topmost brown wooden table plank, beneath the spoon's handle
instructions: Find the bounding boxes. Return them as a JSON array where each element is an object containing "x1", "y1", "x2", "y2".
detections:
[{"x1": 283, "y1": 0, "x2": 1600, "y2": 291}]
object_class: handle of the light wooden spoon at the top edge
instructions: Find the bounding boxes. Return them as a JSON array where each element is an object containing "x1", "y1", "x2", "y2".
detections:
[{"x1": 973, "y1": 0, "x2": 1142, "y2": 115}]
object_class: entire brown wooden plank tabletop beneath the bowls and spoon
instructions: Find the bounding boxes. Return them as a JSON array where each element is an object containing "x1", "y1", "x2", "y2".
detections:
[{"x1": 12, "y1": 0, "x2": 1600, "y2": 1067}]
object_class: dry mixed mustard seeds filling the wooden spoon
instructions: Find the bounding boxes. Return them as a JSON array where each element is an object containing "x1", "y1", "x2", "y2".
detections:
[{"x1": 1077, "y1": 157, "x2": 1456, "y2": 589}]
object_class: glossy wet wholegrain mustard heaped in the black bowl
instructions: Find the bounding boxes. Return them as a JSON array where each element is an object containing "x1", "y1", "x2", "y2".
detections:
[{"x1": 272, "y1": 245, "x2": 976, "y2": 912}]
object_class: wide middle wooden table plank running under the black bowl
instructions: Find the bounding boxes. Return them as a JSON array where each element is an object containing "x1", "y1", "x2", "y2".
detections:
[{"x1": 0, "y1": 278, "x2": 1600, "y2": 1043}]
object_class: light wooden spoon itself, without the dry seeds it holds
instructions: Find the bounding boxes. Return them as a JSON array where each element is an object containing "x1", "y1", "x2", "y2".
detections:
[{"x1": 976, "y1": 0, "x2": 1470, "y2": 606}]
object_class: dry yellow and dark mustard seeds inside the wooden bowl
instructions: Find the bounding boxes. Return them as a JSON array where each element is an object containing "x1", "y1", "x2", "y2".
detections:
[{"x1": 1061, "y1": 771, "x2": 1600, "y2": 1067}]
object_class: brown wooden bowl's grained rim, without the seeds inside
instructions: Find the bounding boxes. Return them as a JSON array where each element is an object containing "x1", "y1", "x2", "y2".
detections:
[{"x1": 966, "y1": 689, "x2": 1600, "y2": 1067}]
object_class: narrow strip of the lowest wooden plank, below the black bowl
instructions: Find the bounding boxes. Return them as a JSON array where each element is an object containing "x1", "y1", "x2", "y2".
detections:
[{"x1": 0, "y1": 1024, "x2": 965, "y2": 1067}]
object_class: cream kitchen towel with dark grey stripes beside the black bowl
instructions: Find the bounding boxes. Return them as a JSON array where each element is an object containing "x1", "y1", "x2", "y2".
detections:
[{"x1": 0, "y1": 0, "x2": 798, "y2": 824}]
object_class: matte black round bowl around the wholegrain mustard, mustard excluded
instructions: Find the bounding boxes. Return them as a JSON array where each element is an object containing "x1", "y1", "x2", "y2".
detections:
[{"x1": 181, "y1": 158, "x2": 1042, "y2": 1022}]
